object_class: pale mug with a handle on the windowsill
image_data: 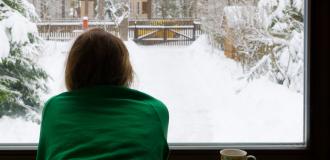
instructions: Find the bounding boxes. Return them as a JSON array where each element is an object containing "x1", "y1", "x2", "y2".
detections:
[{"x1": 220, "y1": 149, "x2": 257, "y2": 160}]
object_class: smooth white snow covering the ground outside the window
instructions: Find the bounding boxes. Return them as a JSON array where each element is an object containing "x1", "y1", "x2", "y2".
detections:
[{"x1": 0, "y1": 36, "x2": 303, "y2": 143}]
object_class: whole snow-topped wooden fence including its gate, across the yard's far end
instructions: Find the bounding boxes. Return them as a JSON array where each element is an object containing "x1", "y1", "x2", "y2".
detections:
[{"x1": 37, "y1": 19, "x2": 202, "y2": 45}]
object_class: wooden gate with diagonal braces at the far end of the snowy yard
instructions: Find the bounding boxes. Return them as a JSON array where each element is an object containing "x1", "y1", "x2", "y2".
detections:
[{"x1": 128, "y1": 19, "x2": 202, "y2": 46}]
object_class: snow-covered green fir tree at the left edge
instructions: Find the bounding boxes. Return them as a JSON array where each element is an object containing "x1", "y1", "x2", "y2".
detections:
[{"x1": 0, "y1": 0, "x2": 48, "y2": 121}]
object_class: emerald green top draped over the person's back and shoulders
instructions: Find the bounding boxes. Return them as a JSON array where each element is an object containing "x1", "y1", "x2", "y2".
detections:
[{"x1": 37, "y1": 86, "x2": 169, "y2": 160}]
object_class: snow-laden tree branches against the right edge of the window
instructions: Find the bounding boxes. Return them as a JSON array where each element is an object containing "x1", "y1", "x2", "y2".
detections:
[{"x1": 232, "y1": 0, "x2": 304, "y2": 92}]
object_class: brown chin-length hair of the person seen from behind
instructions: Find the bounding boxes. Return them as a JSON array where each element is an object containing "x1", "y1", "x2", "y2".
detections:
[{"x1": 65, "y1": 28, "x2": 133, "y2": 91}]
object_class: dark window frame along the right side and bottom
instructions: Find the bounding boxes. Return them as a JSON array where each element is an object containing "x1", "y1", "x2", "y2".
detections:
[{"x1": 0, "y1": 0, "x2": 330, "y2": 160}]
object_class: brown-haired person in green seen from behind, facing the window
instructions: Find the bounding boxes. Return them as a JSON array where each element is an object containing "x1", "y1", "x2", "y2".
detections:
[{"x1": 37, "y1": 28, "x2": 169, "y2": 160}]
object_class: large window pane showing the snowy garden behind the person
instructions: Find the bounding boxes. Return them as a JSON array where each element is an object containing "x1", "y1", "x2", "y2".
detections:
[{"x1": 0, "y1": 0, "x2": 308, "y2": 148}]
